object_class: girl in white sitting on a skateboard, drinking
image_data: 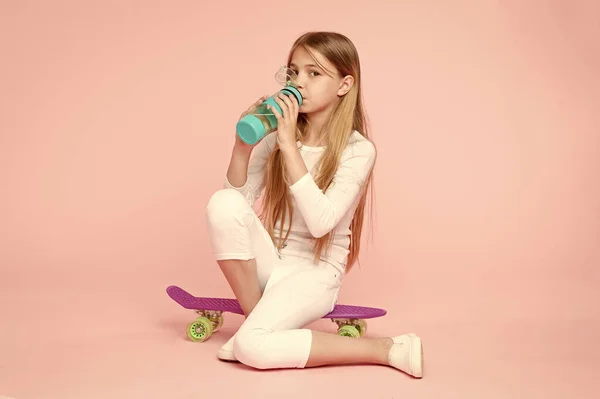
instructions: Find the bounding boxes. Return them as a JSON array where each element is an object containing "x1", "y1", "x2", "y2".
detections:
[{"x1": 206, "y1": 32, "x2": 423, "y2": 378}]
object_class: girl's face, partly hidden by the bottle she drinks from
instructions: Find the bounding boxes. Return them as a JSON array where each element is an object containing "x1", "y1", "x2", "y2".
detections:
[{"x1": 289, "y1": 47, "x2": 352, "y2": 114}]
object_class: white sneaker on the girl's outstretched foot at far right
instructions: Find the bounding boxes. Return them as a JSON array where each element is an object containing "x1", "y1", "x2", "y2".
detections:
[{"x1": 388, "y1": 333, "x2": 423, "y2": 378}]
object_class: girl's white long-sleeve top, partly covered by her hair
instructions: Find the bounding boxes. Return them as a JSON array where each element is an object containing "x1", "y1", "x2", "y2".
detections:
[{"x1": 225, "y1": 131, "x2": 376, "y2": 271}]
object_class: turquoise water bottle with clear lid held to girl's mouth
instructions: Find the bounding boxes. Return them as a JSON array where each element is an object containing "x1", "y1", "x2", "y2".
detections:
[{"x1": 236, "y1": 67, "x2": 302, "y2": 144}]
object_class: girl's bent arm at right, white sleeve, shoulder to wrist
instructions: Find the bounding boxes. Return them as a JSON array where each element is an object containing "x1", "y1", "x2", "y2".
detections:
[{"x1": 281, "y1": 140, "x2": 376, "y2": 238}]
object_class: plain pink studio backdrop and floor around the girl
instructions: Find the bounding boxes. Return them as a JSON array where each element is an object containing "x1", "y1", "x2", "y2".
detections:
[{"x1": 0, "y1": 0, "x2": 600, "y2": 399}]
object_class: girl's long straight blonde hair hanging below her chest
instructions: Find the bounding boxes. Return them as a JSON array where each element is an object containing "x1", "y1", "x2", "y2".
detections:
[{"x1": 261, "y1": 32, "x2": 372, "y2": 271}]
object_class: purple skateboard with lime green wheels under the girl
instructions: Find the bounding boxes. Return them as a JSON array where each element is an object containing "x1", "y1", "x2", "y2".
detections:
[{"x1": 167, "y1": 285, "x2": 387, "y2": 342}]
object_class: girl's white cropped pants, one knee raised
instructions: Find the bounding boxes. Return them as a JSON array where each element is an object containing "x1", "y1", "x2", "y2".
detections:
[{"x1": 206, "y1": 189, "x2": 342, "y2": 369}]
